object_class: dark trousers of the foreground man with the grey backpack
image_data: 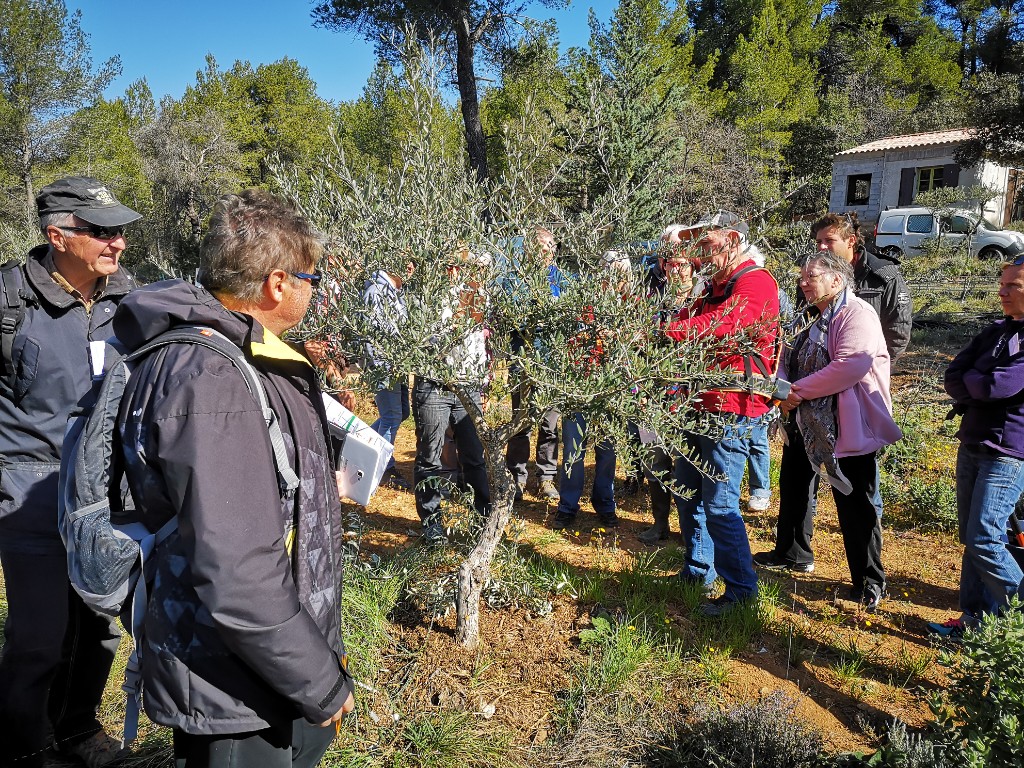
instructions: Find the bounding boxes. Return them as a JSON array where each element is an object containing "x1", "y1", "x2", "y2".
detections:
[{"x1": 174, "y1": 720, "x2": 334, "y2": 768}]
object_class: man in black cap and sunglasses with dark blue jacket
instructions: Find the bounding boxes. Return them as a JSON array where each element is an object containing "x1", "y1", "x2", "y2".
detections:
[{"x1": 0, "y1": 177, "x2": 140, "y2": 768}]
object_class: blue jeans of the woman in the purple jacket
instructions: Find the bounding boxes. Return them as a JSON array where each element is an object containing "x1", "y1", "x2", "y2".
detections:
[{"x1": 956, "y1": 443, "x2": 1024, "y2": 618}]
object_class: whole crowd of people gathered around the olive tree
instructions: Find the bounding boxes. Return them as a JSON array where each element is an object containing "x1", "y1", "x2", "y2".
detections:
[{"x1": 0, "y1": 177, "x2": 1024, "y2": 768}]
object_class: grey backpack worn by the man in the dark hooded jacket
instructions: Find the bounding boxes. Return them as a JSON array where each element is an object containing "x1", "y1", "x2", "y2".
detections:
[{"x1": 57, "y1": 326, "x2": 299, "y2": 744}]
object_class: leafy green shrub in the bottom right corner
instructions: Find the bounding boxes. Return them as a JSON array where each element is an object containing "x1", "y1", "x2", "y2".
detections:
[{"x1": 929, "y1": 598, "x2": 1024, "y2": 768}]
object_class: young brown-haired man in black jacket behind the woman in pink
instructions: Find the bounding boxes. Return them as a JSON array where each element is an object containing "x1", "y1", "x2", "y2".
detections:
[{"x1": 801, "y1": 213, "x2": 913, "y2": 362}]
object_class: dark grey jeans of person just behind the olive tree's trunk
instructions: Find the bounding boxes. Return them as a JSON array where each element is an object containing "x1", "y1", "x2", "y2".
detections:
[{"x1": 413, "y1": 378, "x2": 490, "y2": 522}]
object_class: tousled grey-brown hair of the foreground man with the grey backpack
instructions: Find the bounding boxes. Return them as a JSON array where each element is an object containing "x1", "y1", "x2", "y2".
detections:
[{"x1": 199, "y1": 189, "x2": 324, "y2": 301}]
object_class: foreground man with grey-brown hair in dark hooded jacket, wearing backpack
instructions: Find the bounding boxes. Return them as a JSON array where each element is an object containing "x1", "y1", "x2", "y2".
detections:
[{"x1": 114, "y1": 189, "x2": 353, "y2": 768}]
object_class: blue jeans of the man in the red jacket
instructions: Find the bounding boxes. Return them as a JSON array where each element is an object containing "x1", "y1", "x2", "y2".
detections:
[{"x1": 680, "y1": 414, "x2": 760, "y2": 601}]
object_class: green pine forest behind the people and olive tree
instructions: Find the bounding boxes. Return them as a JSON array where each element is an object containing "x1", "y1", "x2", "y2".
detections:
[{"x1": 6, "y1": 0, "x2": 1024, "y2": 270}]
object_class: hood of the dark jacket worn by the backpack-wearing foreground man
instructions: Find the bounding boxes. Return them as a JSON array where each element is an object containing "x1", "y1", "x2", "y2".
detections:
[{"x1": 114, "y1": 280, "x2": 253, "y2": 350}]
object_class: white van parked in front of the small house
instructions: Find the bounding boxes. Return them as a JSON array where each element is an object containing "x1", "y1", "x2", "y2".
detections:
[{"x1": 874, "y1": 206, "x2": 1024, "y2": 259}]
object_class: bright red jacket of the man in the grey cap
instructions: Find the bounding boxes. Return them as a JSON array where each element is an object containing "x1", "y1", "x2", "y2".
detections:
[{"x1": 665, "y1": 259, "x2": 778, "y2": 417}]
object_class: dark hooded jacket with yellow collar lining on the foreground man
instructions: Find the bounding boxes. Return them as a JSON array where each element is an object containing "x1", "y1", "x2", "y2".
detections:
[{"x1": 114, "y1": 281, "x2": 351, "y2": 735}]
